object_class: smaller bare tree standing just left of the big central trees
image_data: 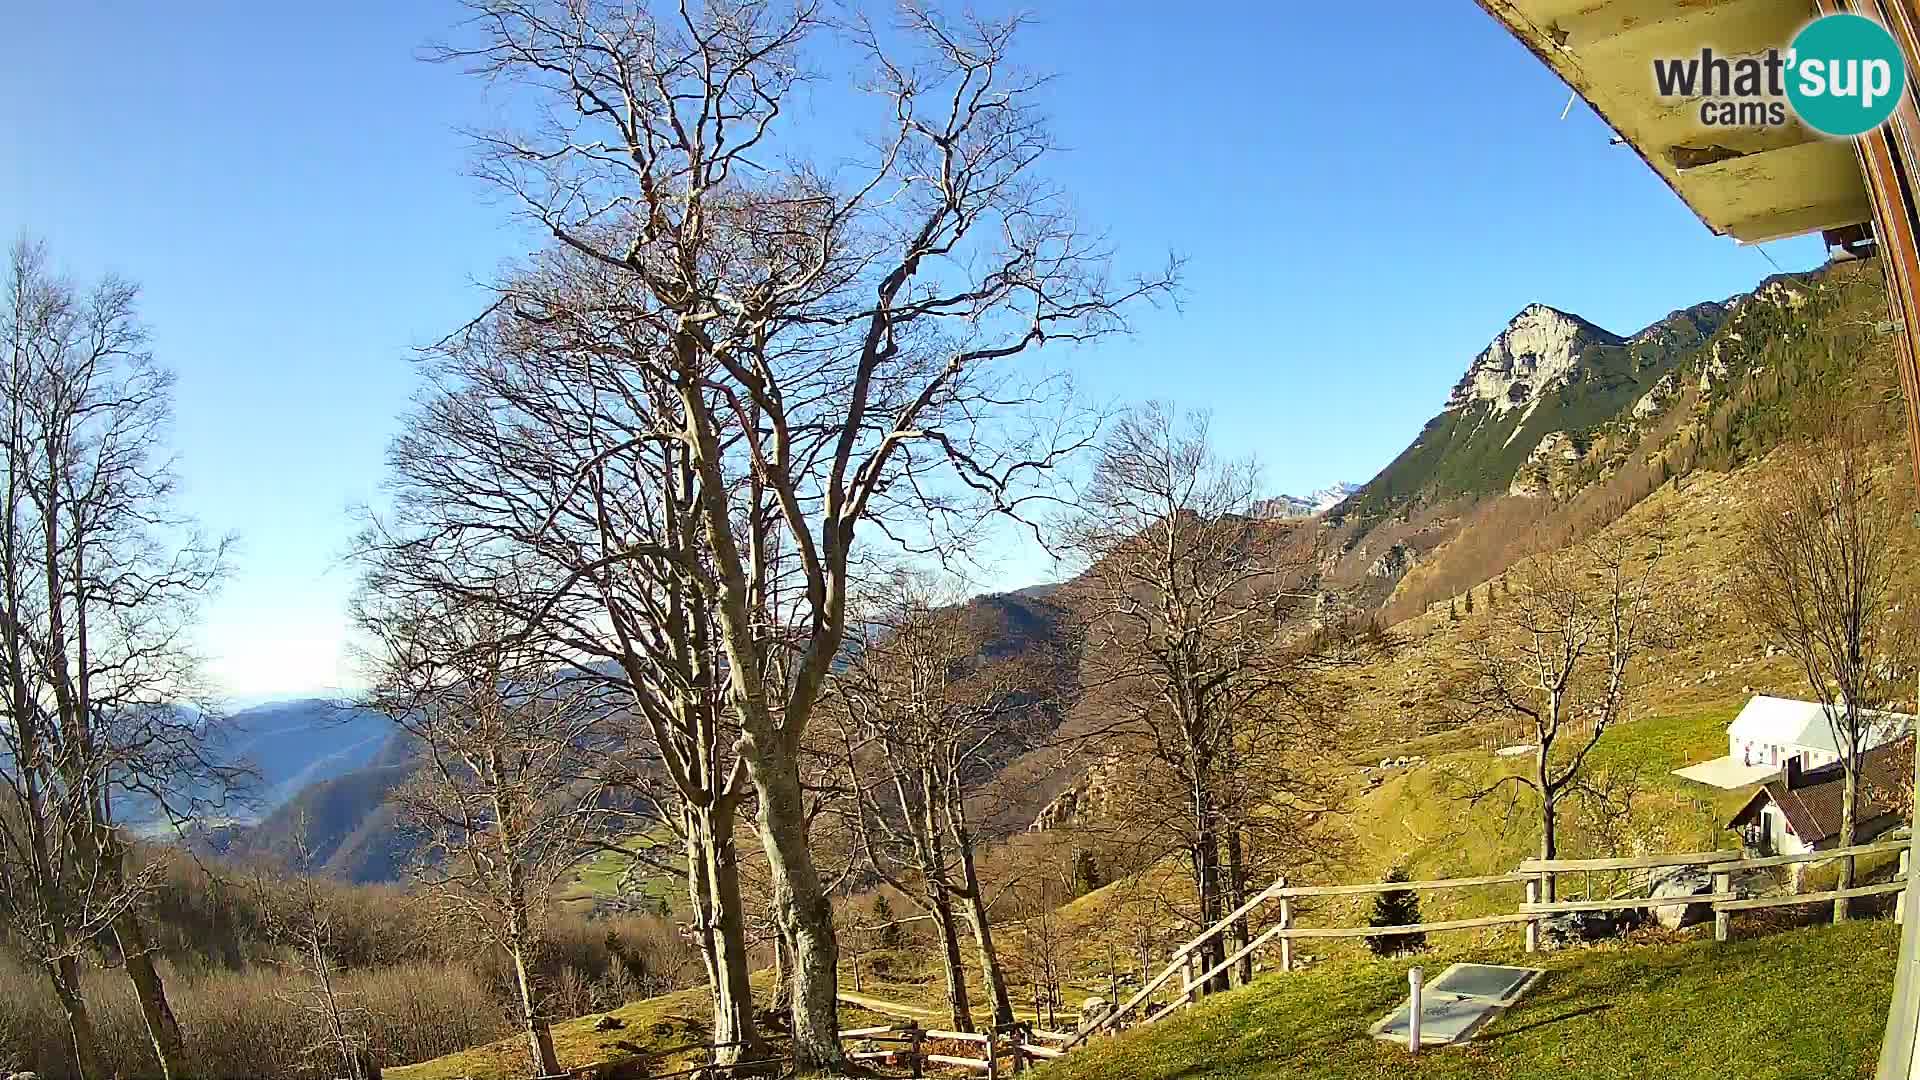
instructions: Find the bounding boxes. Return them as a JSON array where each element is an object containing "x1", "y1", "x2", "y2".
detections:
[{"x1": 359, "y1": 598, "x2": 620, "y2": 1076}]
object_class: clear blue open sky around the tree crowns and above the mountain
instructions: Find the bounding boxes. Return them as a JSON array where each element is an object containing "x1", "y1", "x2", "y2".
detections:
[{"x1": 0, "y1": 0, "x2": 1820, "y2": 698}]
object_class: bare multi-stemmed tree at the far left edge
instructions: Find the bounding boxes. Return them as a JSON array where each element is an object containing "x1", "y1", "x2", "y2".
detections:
[{"x1": 0, "y1": 242, "x2": 238, "y2": 1076}]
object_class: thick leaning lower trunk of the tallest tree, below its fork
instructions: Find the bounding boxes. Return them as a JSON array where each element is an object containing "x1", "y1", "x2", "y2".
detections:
[{"x1": 739, "y1": 734, "x2": 845, "y2": 1072}]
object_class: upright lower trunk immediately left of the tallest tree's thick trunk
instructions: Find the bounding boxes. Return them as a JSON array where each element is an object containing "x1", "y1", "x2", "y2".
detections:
[{"x1": 684, "y1": 799, "x2": 758, "y2": 1065}]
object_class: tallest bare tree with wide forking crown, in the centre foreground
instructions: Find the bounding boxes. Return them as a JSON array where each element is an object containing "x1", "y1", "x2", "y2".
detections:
[{"x1": 428, "y1": 0, "x2": 1171, "y2": 1067}]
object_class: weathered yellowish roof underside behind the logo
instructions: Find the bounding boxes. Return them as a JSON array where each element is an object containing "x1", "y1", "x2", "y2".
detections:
[{"x1": 1480, "y1": 0, "x2": 1872, "y2": 242}]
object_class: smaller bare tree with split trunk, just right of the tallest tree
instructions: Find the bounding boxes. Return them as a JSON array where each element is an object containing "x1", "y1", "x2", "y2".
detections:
[{"x1": 833, "y1": 578, "x2": 1058, "y2": 1030}]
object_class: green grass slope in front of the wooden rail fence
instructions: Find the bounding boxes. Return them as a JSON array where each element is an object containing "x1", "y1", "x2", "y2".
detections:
[{"x1": 1035, "y1": 922, "x2": 1899, "y2": 1080}]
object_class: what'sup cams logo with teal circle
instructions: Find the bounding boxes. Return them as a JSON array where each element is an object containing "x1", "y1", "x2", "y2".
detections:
[{"x1": 1653, "y1": 15, "x2": 1907, "y2": 138}]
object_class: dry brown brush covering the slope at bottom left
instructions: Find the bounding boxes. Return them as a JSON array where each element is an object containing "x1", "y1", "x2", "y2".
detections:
[{"x1": 0, "y1": 855, "x2": 699, "y2": 1080}]
